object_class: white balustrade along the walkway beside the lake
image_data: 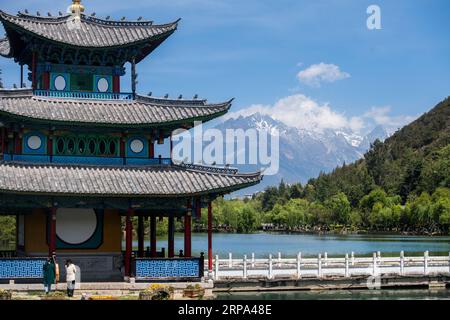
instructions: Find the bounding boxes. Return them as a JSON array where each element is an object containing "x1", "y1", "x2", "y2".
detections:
[{"x1": 205, "y1": 251, "x2": 450, "y2": 280}]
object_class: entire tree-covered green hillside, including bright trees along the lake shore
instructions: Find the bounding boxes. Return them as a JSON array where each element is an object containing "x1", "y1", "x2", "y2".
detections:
[{"x1": 204, "y1": 97, "x2": 450, "y2": 234}]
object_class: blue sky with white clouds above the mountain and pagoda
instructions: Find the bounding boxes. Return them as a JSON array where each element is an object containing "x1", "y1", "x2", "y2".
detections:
[{"x1": 0, "y1": 0, "x2": 450, "y2": 131}]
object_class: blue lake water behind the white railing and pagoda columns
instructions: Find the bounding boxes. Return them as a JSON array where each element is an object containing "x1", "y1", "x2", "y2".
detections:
[{"x1": 134, "y1": 233, "x2": 450, "y2": 258}]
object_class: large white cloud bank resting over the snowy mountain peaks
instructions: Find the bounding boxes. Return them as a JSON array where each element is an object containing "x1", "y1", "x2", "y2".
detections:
[{"x1": 226, "y1": 94, "x2": 363, "y2": 131}]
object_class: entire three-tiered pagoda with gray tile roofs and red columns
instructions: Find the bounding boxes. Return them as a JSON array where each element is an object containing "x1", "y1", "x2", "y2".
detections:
[{"x1": 0, "y1": 0, "x2": 262, "y2": 280}]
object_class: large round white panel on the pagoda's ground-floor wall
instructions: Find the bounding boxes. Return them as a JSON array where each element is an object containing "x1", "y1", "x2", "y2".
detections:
[{"x1": 56, "y1": 209, "x2": 97, "y2": 245}]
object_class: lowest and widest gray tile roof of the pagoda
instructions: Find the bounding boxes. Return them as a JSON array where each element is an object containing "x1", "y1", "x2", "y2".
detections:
[{"x1": 0, "y1": 162, "x2": 262, "y2": 197}]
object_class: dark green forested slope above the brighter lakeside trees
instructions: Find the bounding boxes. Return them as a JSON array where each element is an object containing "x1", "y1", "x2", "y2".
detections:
[{"x1": 309, "y1": 98, "x2": 450, "y2": 205}]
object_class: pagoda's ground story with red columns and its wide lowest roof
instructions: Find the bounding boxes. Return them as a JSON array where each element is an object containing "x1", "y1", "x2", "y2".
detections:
[{"x1": 0, "y1": 162, "x2": 261, "y2": 281}]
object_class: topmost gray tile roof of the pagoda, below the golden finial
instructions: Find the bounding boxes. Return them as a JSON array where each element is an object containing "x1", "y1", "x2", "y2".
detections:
[{"x1": 0, "y1": 11, "x2": 178, "y2": 48}]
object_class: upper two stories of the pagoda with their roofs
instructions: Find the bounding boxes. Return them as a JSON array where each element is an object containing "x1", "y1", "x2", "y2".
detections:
[{"x1": 0, "y1": 1, "x2": 232, "y2": 165}]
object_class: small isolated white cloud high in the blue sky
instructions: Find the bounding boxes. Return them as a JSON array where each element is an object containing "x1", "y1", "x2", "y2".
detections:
[{"x1": 297, "y1": 62, "x2": 350, "y2": 87}]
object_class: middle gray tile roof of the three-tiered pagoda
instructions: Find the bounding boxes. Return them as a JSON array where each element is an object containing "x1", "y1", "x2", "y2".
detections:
[{"x1": 0, "y1": 89, "x2": 232, "y2": 127}]
